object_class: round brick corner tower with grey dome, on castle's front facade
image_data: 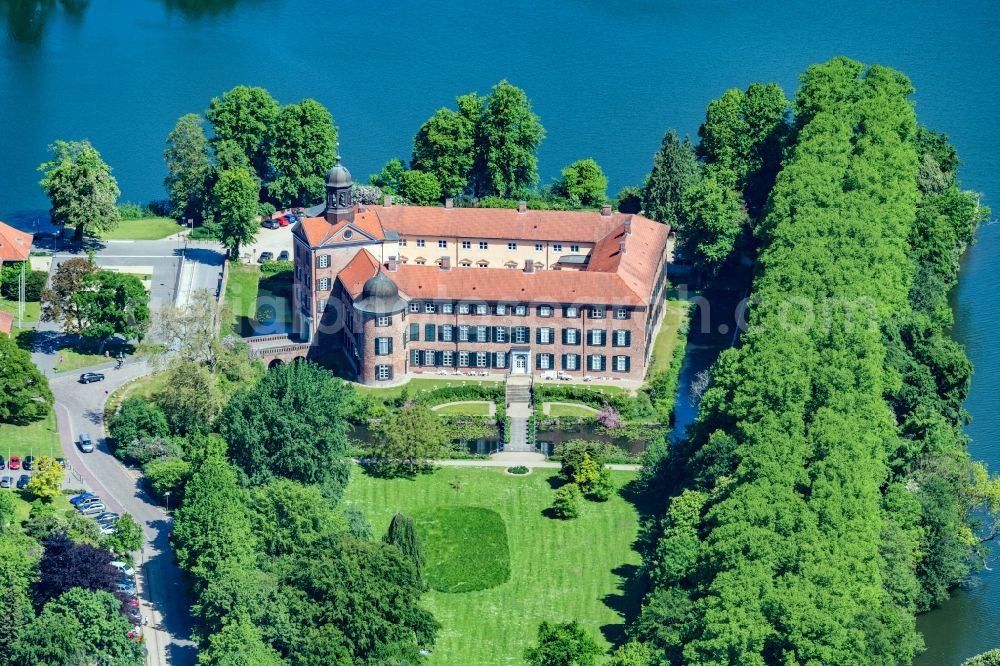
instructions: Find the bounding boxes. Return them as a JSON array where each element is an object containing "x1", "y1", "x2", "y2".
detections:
[{"x1": 354, "y1": 271, "x2": 406, "y2": 384}]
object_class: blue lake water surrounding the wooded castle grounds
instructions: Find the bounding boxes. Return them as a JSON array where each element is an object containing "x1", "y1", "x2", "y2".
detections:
[{"x1": 0, "y1": 0, "x2": 1000, "y2": 665}]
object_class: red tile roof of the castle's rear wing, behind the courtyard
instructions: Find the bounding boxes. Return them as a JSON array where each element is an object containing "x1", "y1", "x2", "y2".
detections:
[{"x1": 368, "y1": 205, "x2": 629, "y2": 243}]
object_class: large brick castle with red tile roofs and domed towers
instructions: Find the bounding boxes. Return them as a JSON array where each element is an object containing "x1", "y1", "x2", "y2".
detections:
[{"x1": 292, "y1": 157, "x2": 669, "y2": 385}]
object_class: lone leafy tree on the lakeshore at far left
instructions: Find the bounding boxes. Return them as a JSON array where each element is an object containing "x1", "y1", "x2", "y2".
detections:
[{"x1": 38, "y1": 140, "x2": 121, "y2": 243}]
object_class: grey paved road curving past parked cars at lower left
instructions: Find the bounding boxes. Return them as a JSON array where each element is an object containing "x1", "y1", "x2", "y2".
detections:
[{"x1": 50, "y1": 361, "x2": 197, "y2": 666}]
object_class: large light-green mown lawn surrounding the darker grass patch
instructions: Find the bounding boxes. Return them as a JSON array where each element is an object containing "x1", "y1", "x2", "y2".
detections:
[{"x1": 345, "y1": 467, "x2": 640, "y2": 665}]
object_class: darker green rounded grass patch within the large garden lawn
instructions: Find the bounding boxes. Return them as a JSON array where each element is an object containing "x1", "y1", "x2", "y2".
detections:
[{"x1": 413, "y1": 506, "x2": 510, "y2": 592}]
